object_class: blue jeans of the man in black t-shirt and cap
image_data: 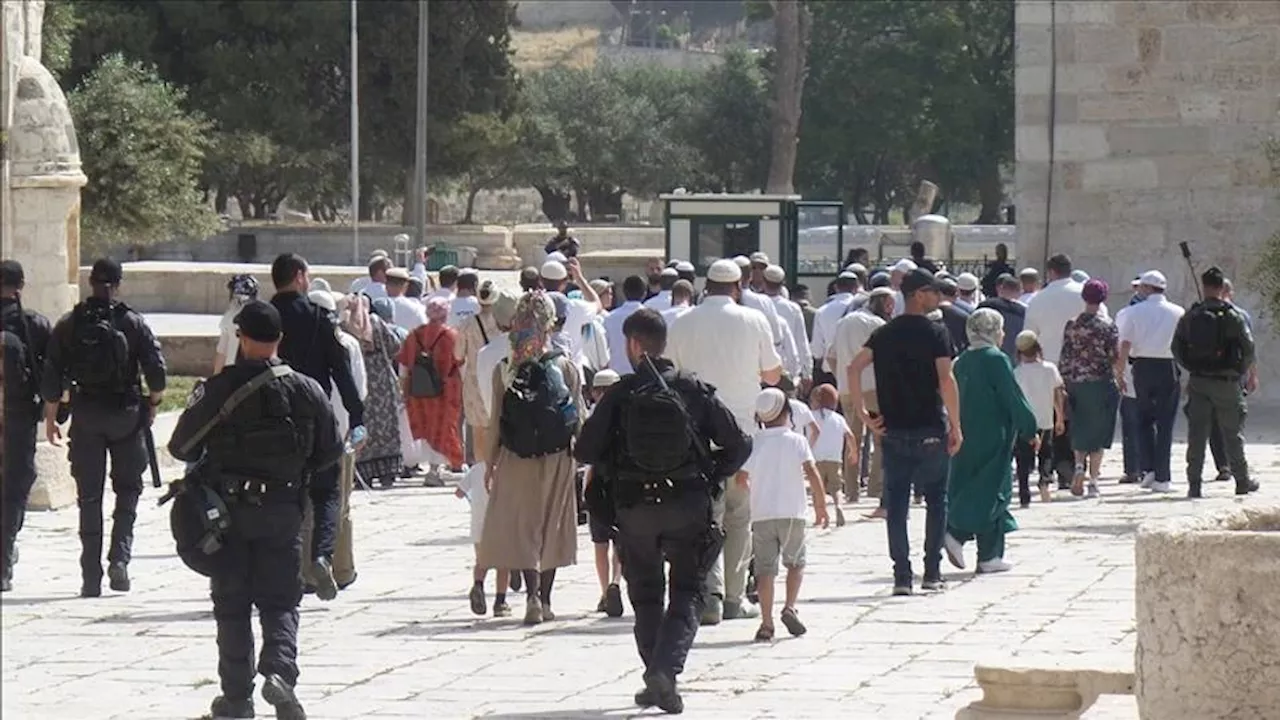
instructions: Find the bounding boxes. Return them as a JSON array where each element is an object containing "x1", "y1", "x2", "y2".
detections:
[{"x1": 883, "y1": 429, "x2": 951, "y2": 585}]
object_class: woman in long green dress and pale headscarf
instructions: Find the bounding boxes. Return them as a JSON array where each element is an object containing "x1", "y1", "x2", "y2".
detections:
[{"x1": 943, "y1": 309, "x2": 1037, "y2": 573}]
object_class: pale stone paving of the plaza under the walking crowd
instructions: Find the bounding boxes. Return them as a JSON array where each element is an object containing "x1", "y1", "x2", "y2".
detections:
[{"x1": 3, "y1": 417, "x2": 1280, "y2": 720}]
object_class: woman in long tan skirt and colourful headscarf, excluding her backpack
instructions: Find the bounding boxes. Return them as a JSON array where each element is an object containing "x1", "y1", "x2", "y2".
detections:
[{"x1": 477, "y1": 291, "x2": 584, "y2": 625}]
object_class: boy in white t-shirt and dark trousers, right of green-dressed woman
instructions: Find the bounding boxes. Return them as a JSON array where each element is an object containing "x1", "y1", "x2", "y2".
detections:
[{"x1": 1014, "y1": 331, "x2": 1070, "y2": 507}]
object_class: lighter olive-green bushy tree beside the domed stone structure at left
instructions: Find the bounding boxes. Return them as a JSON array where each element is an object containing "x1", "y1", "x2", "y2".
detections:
[{"x1": 68, "y1": 55, "x2": 218, "y2": 255}]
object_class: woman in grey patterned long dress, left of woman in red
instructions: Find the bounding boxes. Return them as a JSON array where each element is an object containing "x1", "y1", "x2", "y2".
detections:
[{"x1": 342, "y1": 295, "x2": 403, "y2": 487}]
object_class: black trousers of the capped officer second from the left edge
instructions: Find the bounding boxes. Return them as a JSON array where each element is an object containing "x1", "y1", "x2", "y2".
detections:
[{"x1": 67, "y1": 400, "x2": 147, "y2": 580}]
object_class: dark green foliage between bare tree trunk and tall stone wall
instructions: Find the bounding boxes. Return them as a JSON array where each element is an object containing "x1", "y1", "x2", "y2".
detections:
[{"x1": 797, "y1": 0, "x2": 1014, "y2": 223}]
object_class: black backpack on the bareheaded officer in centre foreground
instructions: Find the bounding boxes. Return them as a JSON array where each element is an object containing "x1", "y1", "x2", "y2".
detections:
[{"x1": 622, "y1": 357, "x2": 707, "y2": 479}]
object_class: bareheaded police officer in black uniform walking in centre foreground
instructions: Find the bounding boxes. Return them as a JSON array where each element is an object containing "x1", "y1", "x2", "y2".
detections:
[{"x1": 575, "y1": 307, "x2": 751, "y2": 714}]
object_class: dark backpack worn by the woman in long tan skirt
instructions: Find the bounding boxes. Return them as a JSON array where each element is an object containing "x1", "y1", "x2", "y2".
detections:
[{"x1": 498, "y1": 350, "x2": 577, "y2": 457}]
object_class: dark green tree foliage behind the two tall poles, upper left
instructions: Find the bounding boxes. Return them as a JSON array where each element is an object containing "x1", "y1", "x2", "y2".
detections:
[{"x1": 64, "y1": 0, "x2": 516, "y2": 219}]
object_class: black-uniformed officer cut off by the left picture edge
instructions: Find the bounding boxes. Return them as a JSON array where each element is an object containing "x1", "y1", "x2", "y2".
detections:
[{"x1": 0, "y1": 260, "x2": 52, "y2": 592}]
